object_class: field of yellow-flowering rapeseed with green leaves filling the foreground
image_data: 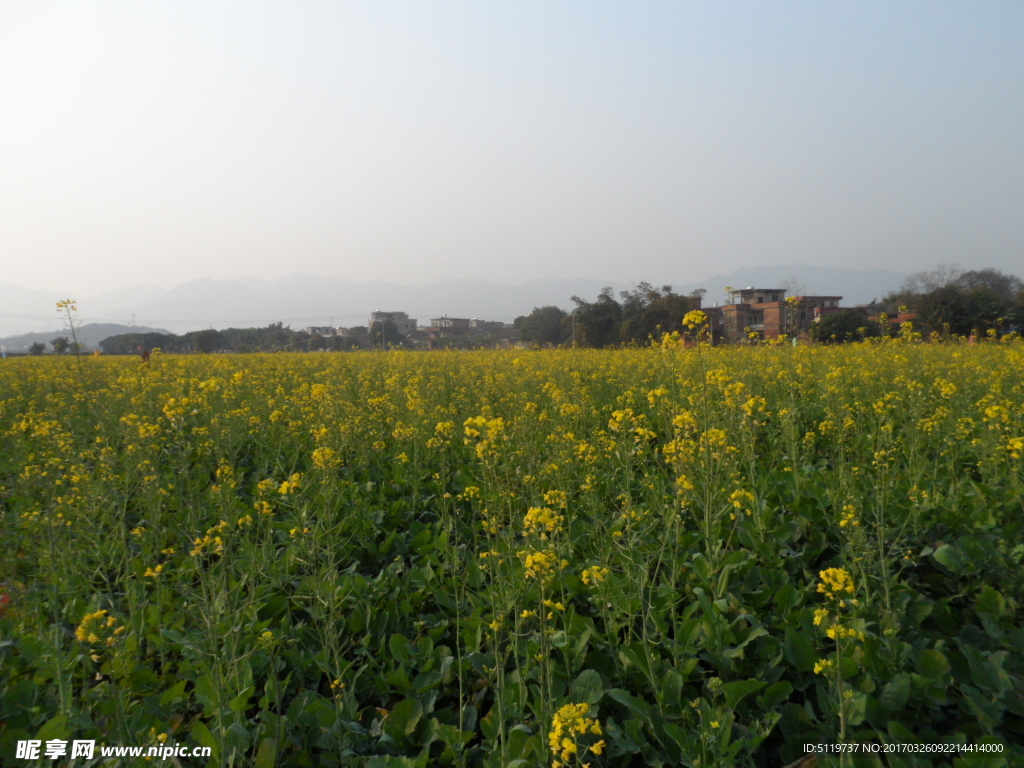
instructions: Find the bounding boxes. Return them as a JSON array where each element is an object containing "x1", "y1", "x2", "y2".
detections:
[{"x1": 0, "y1": 346, "x2": 1024, "y2": 768}]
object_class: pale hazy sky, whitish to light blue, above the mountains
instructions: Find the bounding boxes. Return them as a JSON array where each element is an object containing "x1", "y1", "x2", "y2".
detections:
[{"x1": 0, "y1": 0, "x2": 1024, "y2": 294}]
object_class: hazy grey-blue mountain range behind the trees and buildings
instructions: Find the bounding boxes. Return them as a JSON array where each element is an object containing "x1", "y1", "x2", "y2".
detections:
[{"x1": 0, "y1": 264, "x2": 905, "y2": 339}]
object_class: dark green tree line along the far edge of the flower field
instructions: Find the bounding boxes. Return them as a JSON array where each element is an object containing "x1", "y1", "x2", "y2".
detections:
[{"x1": 92, "y1": 265, "x2": 1024, "y2": 354}]
